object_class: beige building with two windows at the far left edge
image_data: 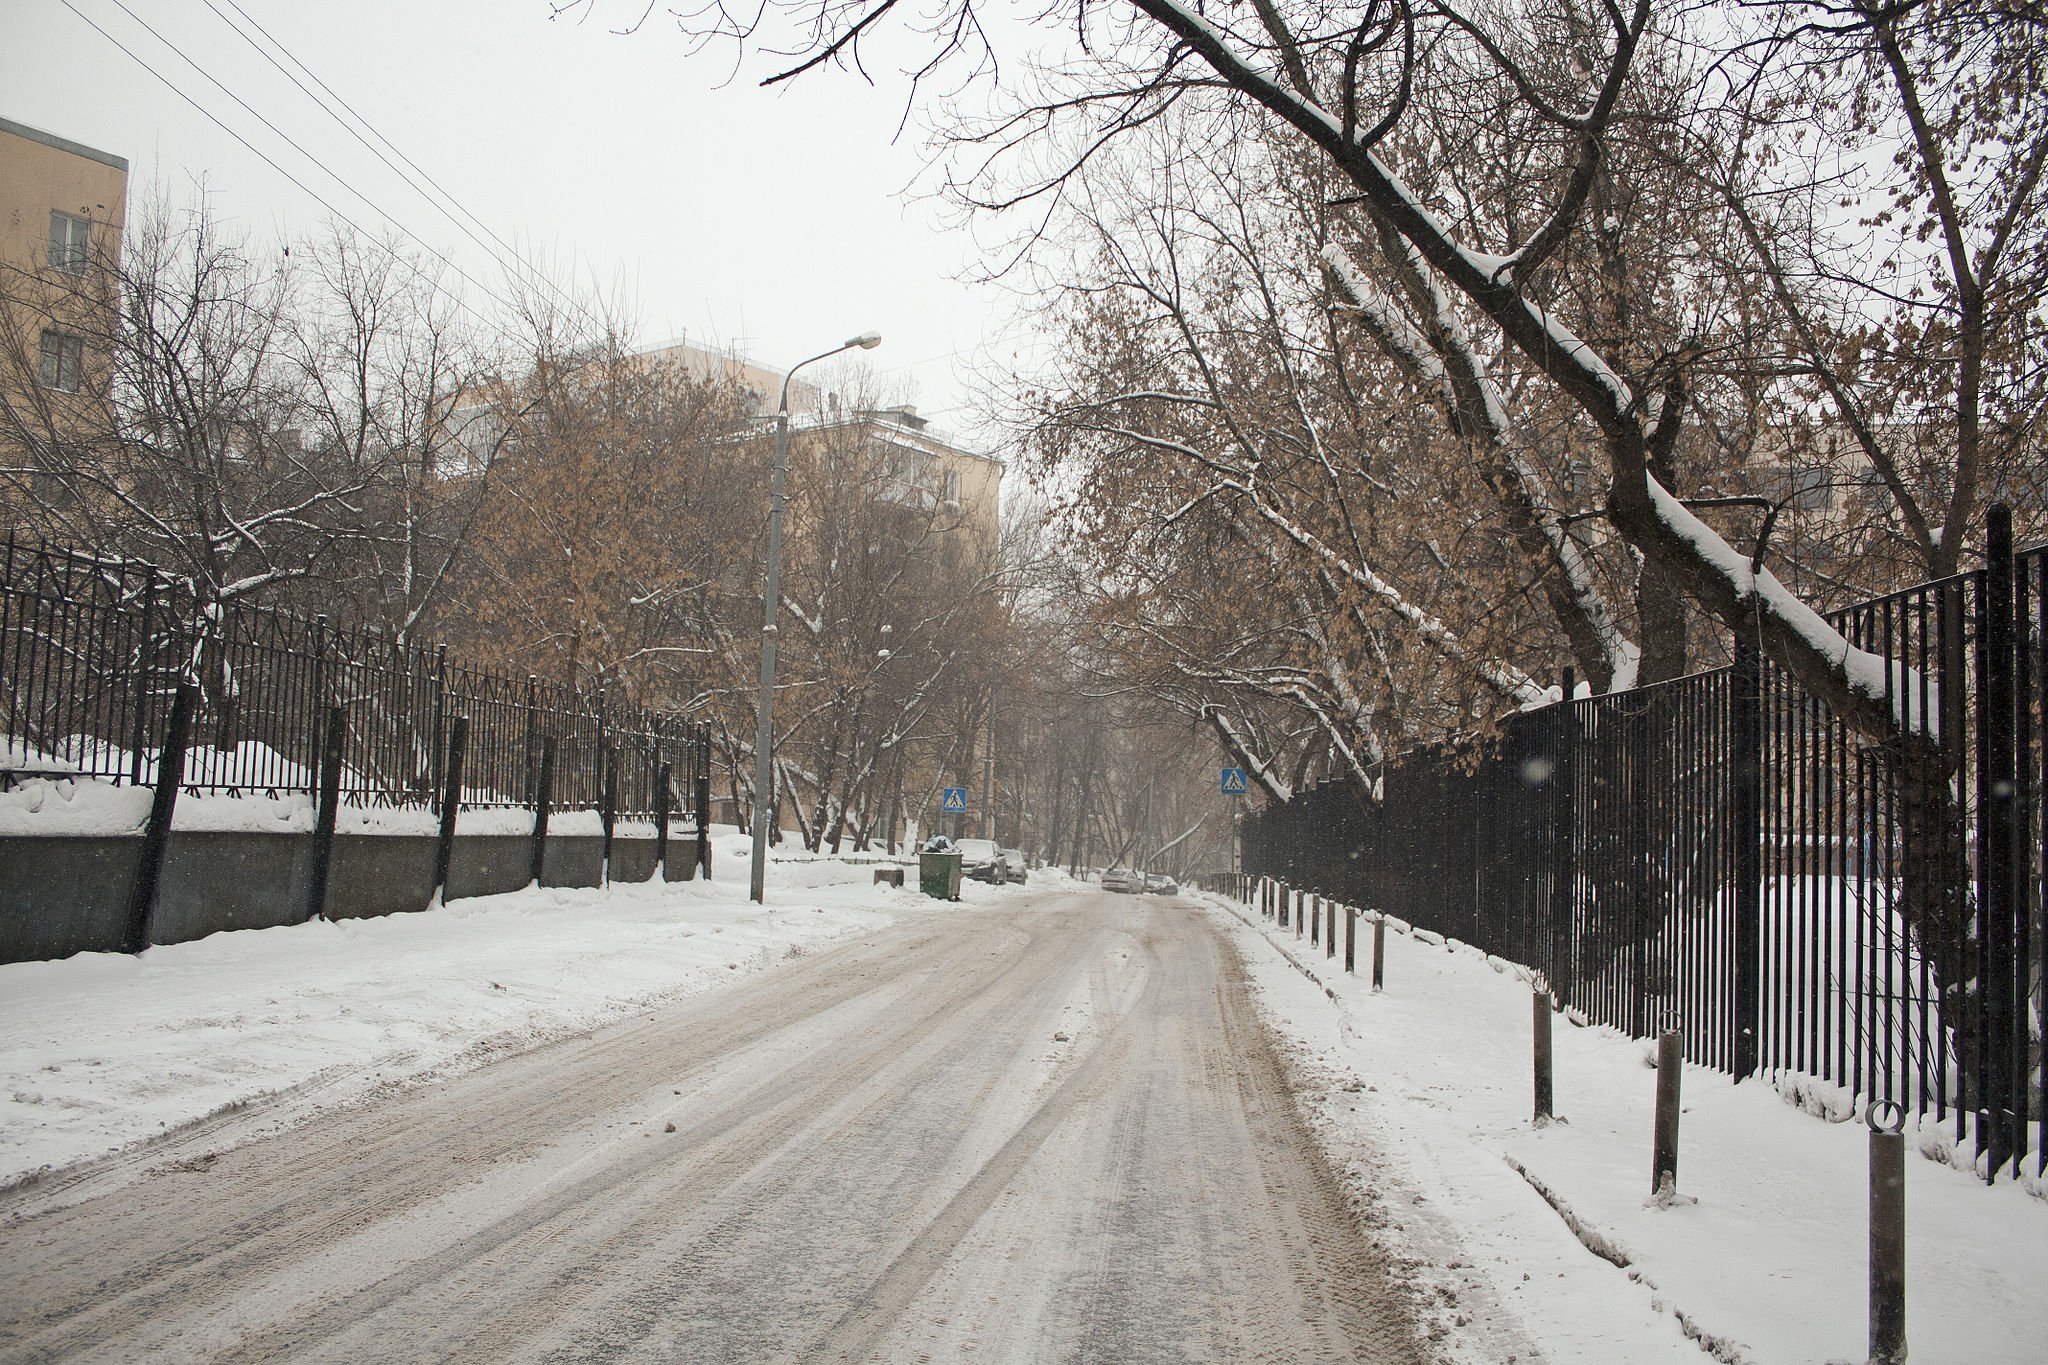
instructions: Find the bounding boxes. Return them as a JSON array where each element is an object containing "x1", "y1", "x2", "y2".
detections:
[{"x1": 0, "y1": 119, "x2": 127, "y2": 464}]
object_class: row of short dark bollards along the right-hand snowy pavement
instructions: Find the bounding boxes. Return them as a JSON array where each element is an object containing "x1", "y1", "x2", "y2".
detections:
[{"x1": 1241, "y1": 878, "x2": 1907, "y2": 1365}]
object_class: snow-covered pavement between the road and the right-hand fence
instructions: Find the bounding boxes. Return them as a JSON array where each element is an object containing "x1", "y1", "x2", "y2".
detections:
[{"x1": 1202, "y1": 896, "x2": 2048, "y2": 1365}]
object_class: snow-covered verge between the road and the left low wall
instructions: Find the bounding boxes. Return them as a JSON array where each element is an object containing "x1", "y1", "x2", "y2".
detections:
[{"x1": 0, "y1": 826, "x2": 913, "y2": 1185}]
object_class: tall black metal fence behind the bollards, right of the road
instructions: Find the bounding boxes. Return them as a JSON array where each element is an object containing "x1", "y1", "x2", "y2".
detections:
[{"x1": 1243, "y1": 510, "x2": 2048, "y2": 1175}]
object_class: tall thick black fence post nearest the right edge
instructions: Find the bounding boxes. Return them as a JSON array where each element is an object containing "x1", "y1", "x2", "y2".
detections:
[{"x1": 1976, "y1": 501, "x2": 2030, "y2": 1181}]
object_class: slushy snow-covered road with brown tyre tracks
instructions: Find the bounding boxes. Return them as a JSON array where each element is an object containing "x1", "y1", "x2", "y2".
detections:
[{"x1": 0, "y1": 888, "x2": 1421, "y2": 1361}]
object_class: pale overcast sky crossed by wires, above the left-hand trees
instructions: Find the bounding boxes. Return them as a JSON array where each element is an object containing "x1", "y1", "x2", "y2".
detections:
[{"x1": 0, "y1": 0, "x2": 1016, "y2": 444}]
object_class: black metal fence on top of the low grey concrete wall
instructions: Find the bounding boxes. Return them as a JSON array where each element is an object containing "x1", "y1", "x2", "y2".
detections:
[{"x1": 0, "y1": 536, "x2": 711, "y2": 819}]
